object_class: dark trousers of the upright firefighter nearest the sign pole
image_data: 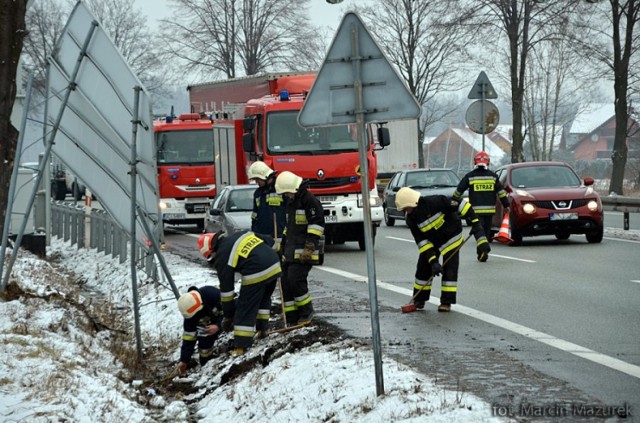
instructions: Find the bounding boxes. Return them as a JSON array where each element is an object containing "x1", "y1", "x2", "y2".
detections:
[{"x1": 282, "y1": 262, "x2": 313, "y2": 325}]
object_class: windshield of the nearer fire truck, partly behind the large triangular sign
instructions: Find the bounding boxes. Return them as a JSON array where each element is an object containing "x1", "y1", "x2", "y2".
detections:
[{"x1": 267, "y1": 110, "x2": 358, "y2": 155}]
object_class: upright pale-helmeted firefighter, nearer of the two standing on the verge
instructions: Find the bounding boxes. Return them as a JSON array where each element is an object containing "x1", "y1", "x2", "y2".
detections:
[{"x1": 276, "y1": 171, "x2": 324, "y2": 324}]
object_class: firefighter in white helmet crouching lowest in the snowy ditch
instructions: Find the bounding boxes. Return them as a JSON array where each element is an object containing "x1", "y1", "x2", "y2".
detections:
[{"x1": 178, "y1": 286, "x2": 222, "y2": 374}]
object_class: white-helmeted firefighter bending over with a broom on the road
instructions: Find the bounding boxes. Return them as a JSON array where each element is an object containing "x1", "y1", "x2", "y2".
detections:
[{"x1": 396, "y1": 187, "x2": 491, "y2": 312}]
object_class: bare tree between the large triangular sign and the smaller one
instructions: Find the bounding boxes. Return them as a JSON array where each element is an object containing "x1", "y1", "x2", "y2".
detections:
[{"x1": 359, "y1": 0, "x2": 478, "y2": 167}]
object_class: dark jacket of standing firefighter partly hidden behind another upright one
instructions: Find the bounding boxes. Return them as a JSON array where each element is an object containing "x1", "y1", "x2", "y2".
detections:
[{"x1": 251, "y1": 182, "x2": 287, "y2": 238}]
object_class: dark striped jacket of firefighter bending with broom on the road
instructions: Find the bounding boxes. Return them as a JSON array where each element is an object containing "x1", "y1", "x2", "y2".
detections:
[{"x1": 407, "y1": 195, "x2": 486, "y2": 262}]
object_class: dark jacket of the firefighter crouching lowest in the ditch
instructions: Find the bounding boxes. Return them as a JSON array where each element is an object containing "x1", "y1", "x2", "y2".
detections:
[{"x1": 180, "y1": 286, "x2": 222, "y2": 363}]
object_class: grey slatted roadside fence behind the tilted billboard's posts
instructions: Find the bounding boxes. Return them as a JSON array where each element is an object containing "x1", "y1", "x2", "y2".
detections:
[{"x1": 51, "y1": 201, "x2": 157, "y2": 279}]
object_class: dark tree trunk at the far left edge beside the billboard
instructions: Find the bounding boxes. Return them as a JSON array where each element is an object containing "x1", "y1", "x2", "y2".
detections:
[{"x1": 0, "y1": 0, "x2": 27, "y2": 238}]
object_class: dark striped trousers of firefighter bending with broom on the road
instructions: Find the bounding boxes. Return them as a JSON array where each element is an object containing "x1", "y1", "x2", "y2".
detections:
[{"x1": 413, "y1": 249, "x2": 460, "y2": 304}]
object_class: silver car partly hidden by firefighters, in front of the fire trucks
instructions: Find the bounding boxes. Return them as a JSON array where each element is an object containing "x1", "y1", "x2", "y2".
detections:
[{"x1": 205, "y1": 184, "x2": 258, "y2": 234}]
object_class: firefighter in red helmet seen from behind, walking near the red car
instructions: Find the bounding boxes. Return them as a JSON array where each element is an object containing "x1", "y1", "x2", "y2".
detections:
[{"x1": 453, "y1": 151, "x2": 509, "y2": 242}]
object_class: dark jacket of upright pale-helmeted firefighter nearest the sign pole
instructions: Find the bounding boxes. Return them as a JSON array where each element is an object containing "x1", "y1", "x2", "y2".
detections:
[{"x1": 284, "y1": 182, "x2": 324, "y2": 264}]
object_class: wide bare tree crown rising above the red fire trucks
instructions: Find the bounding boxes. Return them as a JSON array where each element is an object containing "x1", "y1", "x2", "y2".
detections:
[{"x1": 163, "y1": 0, "x2": 325, "y2": 79}]
